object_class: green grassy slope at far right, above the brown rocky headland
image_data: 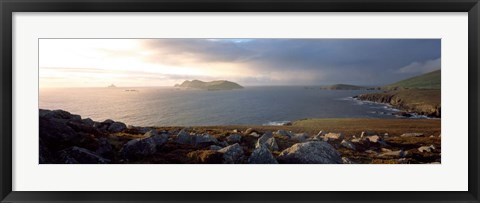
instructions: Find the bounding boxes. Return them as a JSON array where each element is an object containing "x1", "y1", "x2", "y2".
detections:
[{"x1": 383, "y1": 70, "x2": 441, "y2": 89}]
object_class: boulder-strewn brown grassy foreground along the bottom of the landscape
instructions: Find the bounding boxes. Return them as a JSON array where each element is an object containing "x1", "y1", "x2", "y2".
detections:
[{"x1": 39, "y1": 110, "x2": 441, "y2": 164}]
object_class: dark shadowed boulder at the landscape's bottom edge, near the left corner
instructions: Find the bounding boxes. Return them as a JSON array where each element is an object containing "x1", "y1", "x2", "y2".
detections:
[{"x1": 59, "y1": 146, "x2": 110, "y2": 164}]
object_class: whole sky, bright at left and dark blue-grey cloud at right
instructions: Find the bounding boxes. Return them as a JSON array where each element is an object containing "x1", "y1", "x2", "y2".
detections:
[{"x1": 39, "y1": 39, "x2": 441, "y2": 88}]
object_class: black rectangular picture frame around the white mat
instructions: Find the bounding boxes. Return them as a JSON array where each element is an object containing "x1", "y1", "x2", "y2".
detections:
[{"x1": 0, "y1": 0, "x2": 480, "y2": 202}]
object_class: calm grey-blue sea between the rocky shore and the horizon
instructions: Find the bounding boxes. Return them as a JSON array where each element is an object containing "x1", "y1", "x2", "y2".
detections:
[{"x1": 39, "y1": 86, "x2": 408, "y2": 126}]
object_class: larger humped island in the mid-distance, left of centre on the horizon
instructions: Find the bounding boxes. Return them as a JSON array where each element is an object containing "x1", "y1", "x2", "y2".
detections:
[{"x1": 174, "y1": 80, "x2": 243, "y2": 90}]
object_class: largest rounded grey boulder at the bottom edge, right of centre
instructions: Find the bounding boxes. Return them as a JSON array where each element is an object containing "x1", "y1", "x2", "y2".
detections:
[{"x1": 277, "y1": 141, "x2": 342, "y2": 164}]
